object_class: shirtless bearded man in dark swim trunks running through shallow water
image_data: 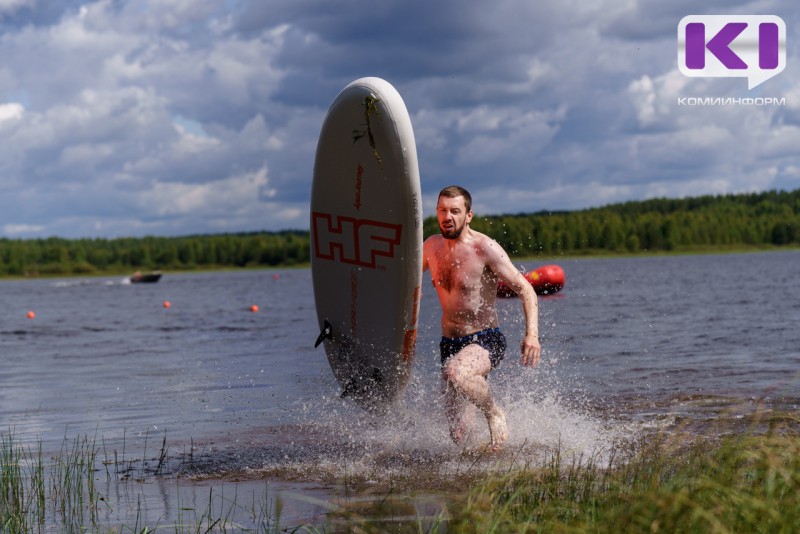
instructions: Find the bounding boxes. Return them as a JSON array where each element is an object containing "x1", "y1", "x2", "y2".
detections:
[{"x1": 422, "y1": 186, "x2": 541, "y2": 450}]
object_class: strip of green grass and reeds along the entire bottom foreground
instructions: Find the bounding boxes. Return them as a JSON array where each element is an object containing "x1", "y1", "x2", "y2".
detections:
[{"x1": 0, "y1": 413, "x2": 800, "y2": 534}]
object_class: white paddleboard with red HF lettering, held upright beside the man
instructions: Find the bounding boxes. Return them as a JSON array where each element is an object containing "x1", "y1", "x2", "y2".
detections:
[{"x1": 311, "y1": 78, "x2": 422, "y2": 411}]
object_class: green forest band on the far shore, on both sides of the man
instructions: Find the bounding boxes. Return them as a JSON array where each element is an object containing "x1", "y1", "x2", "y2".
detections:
[{"x1": 0, "y1": 189, "x2": 800, "y2": 276}]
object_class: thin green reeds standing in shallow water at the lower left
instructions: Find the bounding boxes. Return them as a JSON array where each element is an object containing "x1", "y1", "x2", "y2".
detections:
[{"x1": 0, "y1": 431, "x2": 290, "y2": 534}]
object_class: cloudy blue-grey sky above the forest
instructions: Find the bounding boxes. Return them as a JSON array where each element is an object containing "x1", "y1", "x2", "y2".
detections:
[{"x1": 0, "y1": 0, "x2": 800, "y2": 238}]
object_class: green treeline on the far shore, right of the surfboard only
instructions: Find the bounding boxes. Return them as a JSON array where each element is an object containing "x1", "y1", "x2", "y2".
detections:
[{"x1": 456, "y1": 189, "x2": 800, "y2": 256}]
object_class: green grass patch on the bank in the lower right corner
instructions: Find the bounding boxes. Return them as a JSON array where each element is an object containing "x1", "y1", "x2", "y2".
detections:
[{"x1": 449, "y1": 421, "x2": 800, "y2": 534}]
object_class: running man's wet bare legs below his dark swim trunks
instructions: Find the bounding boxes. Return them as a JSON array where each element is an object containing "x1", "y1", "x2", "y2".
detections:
[{"x1": 442, "y1": 344, "x2": 508, "y2": 450}]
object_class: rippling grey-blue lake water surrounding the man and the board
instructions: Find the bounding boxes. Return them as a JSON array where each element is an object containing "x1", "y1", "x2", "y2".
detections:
[{"x1": 0, "y1": 250, "x2": 800, "y2": 522}]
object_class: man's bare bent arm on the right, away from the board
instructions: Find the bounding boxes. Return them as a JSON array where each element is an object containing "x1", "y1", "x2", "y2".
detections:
[{"x1": 487, "y1": 241, "x2": 542, "y2": 367}]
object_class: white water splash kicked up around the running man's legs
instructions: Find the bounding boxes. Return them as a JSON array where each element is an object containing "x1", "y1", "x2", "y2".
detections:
[{"x1": 177, "y1": 354, "x2": 636, "y2": 487}]
